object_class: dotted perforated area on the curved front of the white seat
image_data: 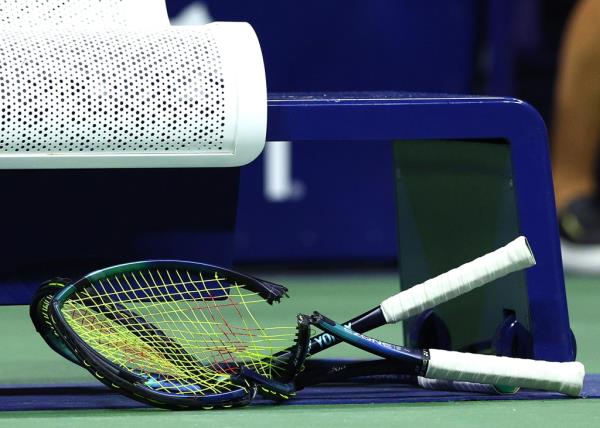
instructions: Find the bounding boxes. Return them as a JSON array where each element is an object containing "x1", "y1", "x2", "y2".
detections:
[{"x1": 0, "y1": 25, "x2": 232, "y2": 153}]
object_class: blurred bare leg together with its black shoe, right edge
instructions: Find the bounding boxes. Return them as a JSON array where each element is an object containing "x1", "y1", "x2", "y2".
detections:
[{"x1": 551, "y1": 0, "x2": 600, "y2": 275}]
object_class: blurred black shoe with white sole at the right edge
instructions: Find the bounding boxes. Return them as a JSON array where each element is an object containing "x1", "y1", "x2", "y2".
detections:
[{"x1": 558, "y1": 196, "x2": 600, "y2": 275}]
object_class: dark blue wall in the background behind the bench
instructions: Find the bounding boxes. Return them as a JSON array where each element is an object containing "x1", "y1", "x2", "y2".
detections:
[{"x1": 168, "y1": 0, "x2": 572, "y2": 262}]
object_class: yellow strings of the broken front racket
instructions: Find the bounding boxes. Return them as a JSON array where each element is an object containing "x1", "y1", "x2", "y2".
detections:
[{"x1": 63, "y1": 269, "x2": 295, "y2": 394}]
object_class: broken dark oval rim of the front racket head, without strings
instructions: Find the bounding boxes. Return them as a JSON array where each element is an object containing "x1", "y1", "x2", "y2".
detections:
[{"x1": 46, "y1": 261, "x2": 310, "y2": 409}]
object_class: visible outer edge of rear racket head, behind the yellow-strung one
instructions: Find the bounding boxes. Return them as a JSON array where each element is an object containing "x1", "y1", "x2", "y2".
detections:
[{"x1": 29, "y1": 278, "x2": 81, "y2": 365}]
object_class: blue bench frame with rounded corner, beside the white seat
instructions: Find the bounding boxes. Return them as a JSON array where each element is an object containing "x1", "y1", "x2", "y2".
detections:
[{"x1": 267, "y1": 93, "x2": 575, "y2": 361}]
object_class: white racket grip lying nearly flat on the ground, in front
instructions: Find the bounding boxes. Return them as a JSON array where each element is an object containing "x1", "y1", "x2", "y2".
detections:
[{"x1": 426, "y1": 349, "x2": 585, "y2": 396}]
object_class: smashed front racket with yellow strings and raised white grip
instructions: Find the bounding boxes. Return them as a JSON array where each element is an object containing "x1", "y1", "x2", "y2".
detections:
[{"x1": 43, "y1": 237, "x2": 534, "y2": 408}]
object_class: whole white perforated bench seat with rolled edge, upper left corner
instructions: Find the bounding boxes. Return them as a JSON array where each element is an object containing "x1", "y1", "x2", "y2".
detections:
[{"x1": 0, "y1": 0, "x2": 267, "y2": 168}]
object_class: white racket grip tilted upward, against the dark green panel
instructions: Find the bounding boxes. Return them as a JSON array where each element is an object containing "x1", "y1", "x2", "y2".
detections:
[{"x1": 381, "y1": 236, "x2": 535, "y2": 323}]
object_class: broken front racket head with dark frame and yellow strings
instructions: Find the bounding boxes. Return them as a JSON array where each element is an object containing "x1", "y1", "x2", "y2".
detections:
[{"x1": 50, "y1": 260, "x2": 308, "y2": 409}]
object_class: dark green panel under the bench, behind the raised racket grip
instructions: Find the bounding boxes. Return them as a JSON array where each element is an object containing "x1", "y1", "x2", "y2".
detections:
[{"x1": 394, "y1": 141, "x2": 529, "y2": 349}]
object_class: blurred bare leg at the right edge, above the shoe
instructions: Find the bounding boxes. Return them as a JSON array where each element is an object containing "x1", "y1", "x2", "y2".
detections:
[{"x1": 551, "y1": 0, "x2": 600, "y2": 211}]
